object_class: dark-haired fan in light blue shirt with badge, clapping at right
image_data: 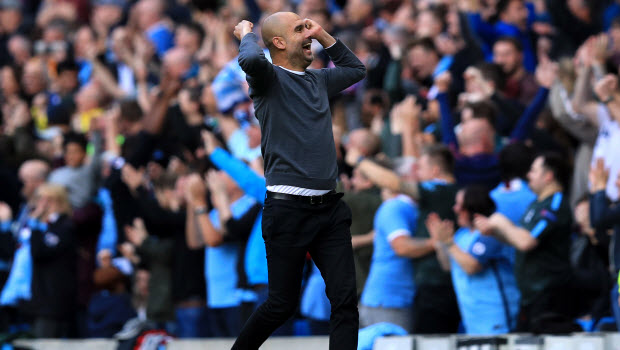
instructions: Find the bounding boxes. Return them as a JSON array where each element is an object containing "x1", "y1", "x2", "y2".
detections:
[{"x1": 426, "y1": 186, "x2": 519, "y2": 334}]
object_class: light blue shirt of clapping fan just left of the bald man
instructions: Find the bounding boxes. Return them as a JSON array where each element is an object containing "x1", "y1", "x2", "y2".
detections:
[{"x1": 205, "y1": 195, "x2": 256, "y2": 308}]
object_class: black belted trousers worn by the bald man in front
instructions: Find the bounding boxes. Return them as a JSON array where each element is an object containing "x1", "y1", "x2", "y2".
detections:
[{"x1": 233, "y1": 196, "x2": 359, "y2": 350}]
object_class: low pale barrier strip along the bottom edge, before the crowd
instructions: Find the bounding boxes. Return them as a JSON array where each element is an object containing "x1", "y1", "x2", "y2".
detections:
[{"x1": 8, "y1": 333, "x2": 620, "y2": 350}]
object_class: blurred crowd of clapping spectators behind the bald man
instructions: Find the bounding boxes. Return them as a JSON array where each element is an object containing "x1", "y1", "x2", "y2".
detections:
[{"x1": 0, "y1": 0, "x2": 620, "y2": 339}]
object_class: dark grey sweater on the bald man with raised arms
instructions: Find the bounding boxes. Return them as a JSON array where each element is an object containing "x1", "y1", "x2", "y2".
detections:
[{"x1": 239, "y1": 33, "x2": 366, "y2": 190}]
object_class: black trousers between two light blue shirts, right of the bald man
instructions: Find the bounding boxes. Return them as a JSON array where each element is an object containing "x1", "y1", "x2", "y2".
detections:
[{"x1": 413, "y1": 285, "x2": 461, "y2": 334}]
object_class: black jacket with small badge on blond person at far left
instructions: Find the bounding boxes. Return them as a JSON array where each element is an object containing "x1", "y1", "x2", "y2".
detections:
[{"x1": 30, "y1": 215, "x2": 77, "y2": 321}]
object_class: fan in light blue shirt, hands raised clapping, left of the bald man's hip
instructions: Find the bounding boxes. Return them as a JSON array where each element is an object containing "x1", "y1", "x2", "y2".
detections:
[{"x1": 186, "y1": 171, "x2": 260, "y2": 337}]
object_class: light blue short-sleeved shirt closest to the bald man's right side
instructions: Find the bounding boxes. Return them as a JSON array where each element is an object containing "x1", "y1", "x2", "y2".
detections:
[{"x1": 361, "y1": 195, "x2": 418, "y2": 308}]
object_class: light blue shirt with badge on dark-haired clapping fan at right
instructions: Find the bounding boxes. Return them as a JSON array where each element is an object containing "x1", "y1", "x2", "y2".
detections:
[{"x1": 451, "y1": 228, "x2": 520, "y2": 335}]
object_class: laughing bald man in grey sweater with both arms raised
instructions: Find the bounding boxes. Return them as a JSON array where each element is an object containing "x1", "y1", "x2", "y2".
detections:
[{"x1": 233, "y1": 12, "x2": 366, "y2": 350}]
